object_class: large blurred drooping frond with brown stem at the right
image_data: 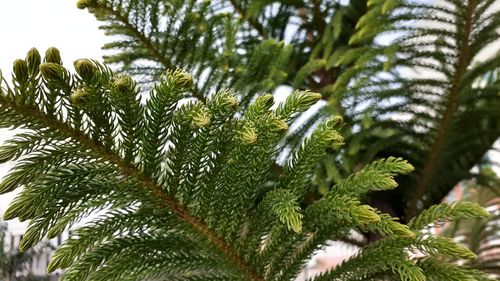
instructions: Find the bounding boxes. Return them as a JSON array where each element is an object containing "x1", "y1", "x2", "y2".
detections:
[{"x1": 327, "y1": 1, "x2": 500, "y2": 221}]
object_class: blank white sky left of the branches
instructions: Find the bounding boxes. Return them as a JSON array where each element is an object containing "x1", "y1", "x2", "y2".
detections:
[{"x1": 0, "y1": 0, "x2": 106, "y2": 230}]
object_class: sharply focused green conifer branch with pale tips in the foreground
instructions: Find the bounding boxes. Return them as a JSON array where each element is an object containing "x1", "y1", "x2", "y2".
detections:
[{"x1": 0, "y1": 49, "x2": 492, "y2": 280}]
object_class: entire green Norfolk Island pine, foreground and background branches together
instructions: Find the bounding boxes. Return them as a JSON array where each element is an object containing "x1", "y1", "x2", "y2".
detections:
[{"x1": 0, "y1": 0, "x2": 500, "y2": 281}]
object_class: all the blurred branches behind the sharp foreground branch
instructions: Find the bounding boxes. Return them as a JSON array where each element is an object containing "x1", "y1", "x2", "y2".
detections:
[{"x1": 74, "y1": 0, "x2": 500, "y2": 221}]
